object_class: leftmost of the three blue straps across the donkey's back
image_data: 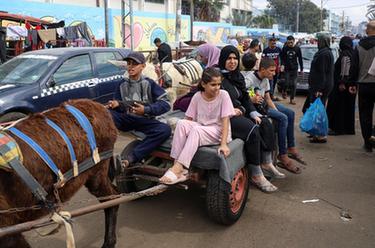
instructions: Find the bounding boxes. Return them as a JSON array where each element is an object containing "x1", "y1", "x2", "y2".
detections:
[{"x1": 8, "y1": 127, "x2": 64, "y2": 182}]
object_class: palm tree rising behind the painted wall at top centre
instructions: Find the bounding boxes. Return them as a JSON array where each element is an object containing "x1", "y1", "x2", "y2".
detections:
[{"x1": 194, "y1": 0, "x2": 226, "y2": 22}]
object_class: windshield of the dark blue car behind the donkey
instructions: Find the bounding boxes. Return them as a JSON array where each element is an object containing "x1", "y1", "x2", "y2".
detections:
[{"x1": 0, "y1": 54, "x2": 57, "y2": 84}]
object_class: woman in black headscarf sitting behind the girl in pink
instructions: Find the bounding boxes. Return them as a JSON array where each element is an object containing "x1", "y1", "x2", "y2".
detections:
[{"x1": 219, "y1": 45, "x2": 277, "y2": 192}]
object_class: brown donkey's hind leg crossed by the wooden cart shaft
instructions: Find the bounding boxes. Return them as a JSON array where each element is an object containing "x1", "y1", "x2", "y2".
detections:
[{"x1": 86, "y1": 161, "x2": 119, "y2": 248}]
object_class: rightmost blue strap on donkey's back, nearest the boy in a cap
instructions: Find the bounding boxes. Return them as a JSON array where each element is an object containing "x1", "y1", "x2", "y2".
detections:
[{"x1": 65, "y1": 104, "x2": 100, "y2": 164}]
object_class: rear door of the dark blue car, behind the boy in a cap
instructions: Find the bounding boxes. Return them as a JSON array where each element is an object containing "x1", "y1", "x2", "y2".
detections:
[{"x1": 93, "y1": 51, "x2": 125, "y2": 103}]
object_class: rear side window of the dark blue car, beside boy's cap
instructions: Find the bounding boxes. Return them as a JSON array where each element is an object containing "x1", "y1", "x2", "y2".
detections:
[{"x1": 94, "y1": 52, "x2": 123, "y2": 76}]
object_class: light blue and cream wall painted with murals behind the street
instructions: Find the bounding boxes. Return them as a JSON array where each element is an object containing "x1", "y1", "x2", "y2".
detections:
[{"x1": 0, "y1": 0, "x2": 280, "y2": 50}]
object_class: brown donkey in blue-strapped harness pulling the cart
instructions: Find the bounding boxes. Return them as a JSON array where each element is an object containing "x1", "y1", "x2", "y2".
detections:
[{"x1": 0, "y1": 99, "x2": 118, "y2": 248}]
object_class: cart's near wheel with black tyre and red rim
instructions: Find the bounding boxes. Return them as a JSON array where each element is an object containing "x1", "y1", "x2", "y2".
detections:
[{"x1": 206, "y1": 166, "x2": 249, "y2": 225}]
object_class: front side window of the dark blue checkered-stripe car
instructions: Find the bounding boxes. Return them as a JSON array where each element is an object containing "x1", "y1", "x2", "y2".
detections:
[{"x1": 53, "y1": 54, "x2": 94, "y2": 85}]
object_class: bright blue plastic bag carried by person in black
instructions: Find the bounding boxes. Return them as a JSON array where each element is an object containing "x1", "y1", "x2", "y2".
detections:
[{"x1": 299, "y1": 98, "x2": 328, "y2": 136}]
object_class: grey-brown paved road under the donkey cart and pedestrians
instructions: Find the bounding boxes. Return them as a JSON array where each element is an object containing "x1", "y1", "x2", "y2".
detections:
[{"x1": 26, "y1": 97, "x2": 375, "y2": 248}]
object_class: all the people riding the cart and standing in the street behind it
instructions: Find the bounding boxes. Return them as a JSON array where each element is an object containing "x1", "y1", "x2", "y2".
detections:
[{"x1": 107, "y1": 21, "x2": 375, "y2": 193}]
